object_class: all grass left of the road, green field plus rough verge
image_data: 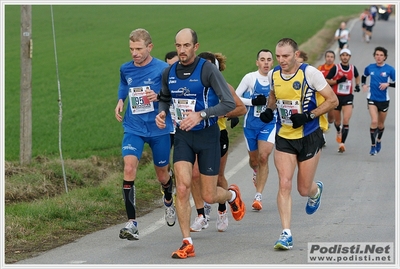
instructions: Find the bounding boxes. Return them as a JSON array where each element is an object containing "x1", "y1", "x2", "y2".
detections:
[{"x1": 4, "y1": 5, "x2": 365, "y2": 263}]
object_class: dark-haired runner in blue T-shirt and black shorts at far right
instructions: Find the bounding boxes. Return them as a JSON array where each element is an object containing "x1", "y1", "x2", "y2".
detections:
[{"x1": 361, "y1": 47, "x2": 396, "y2": 156}]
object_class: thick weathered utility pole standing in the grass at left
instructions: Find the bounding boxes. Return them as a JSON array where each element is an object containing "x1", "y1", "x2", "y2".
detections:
[{"x1": 19, "y1": 5, "x2": 33, "y2": 165}]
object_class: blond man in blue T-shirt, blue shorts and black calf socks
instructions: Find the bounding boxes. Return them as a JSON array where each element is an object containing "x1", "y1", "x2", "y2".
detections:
[{"x1": 115, "y1": 28, "x2": 176, "y2": 240}]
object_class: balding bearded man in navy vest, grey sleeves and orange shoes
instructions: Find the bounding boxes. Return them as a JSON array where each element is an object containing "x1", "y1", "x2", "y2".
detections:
[{"x1": 156, "y1": 28, "x2": 246, "y2": 259}]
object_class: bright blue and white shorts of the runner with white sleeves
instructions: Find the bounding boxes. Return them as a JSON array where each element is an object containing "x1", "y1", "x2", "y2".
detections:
[{"x1": 243, "y1": 123, "x2": 276, "y2": 151}]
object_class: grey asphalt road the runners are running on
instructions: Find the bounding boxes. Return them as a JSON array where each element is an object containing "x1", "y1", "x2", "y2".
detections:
[{"x1": 13, "y1": 16, "x2": 399, "y2": 268}]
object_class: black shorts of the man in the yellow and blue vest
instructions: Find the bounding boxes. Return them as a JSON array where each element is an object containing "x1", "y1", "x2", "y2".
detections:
[{"x1": 275, "y1": 128, "x2": 325, "y2": 162}]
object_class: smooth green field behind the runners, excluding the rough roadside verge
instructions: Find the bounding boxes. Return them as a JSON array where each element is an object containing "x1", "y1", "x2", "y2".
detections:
[{"x1": 5, "y1": 5, "x2": 365, "y2": 161}]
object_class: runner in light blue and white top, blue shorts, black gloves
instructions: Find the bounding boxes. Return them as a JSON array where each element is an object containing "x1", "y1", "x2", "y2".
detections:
[{"x1": 236, "y1": 49, "x2": 276, "y2": 211}]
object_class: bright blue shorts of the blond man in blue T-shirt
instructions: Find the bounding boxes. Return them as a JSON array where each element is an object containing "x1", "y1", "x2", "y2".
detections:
[{"x1": 122, "y1": 133, "x2": 171, "y2": 167}]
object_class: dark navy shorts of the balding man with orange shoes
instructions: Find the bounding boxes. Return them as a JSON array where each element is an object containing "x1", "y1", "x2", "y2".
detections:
[{"x1": 173, "y1": 124, "x2": 221, "y2": 176}]
